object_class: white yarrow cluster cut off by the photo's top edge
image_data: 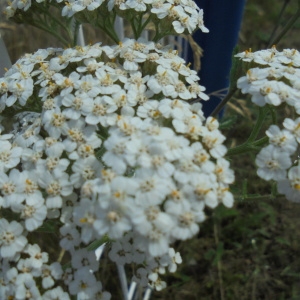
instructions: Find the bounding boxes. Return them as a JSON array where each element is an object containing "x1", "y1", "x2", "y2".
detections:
[{"x1": 5, "y1": 0, "x2": 208, "y2": 34}]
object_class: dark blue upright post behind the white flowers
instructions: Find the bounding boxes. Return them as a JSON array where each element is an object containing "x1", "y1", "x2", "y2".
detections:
[{"x1": 188, "y1": 0, "x2": 246, "y2": 116}]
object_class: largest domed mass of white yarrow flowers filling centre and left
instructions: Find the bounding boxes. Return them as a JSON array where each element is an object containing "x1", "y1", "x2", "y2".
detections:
[{"x1": 0, "y1": 39, "x2": 234, "y2": 299}]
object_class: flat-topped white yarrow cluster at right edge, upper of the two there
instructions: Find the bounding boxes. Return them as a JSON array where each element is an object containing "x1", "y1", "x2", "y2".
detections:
[{"x1": 236, "y1": 47, "x2": 300, "y2": 107}]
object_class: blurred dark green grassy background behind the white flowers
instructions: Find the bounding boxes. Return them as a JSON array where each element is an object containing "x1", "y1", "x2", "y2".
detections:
[{"x1": 0, "y1": 0, "x2": 300, "y2": 300}]
